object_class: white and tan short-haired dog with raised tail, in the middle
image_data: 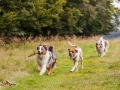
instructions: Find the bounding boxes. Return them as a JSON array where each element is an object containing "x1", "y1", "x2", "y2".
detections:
[{"x1": 68, "y1": 41, "x2": 83, "y2": 72}]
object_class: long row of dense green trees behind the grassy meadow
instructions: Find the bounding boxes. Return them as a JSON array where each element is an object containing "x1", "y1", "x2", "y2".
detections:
[{"x1": 0, "y1": 0, "x2": 118, "y2": 36}]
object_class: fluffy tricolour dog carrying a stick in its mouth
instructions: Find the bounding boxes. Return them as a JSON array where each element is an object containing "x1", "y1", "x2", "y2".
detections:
[{"x1": 37, "y1": 44, "x2": 56, "y2": 75}]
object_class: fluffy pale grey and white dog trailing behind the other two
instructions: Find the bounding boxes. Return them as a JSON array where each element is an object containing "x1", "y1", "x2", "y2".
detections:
[{"x1": 96, "y1": 37, "x2": 109, "y2": 57}]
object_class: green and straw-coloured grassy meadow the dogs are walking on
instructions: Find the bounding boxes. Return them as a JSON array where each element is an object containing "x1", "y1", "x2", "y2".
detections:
[{"x1": 0, "y1": 36, "x2": 120, "y2": 90}]
